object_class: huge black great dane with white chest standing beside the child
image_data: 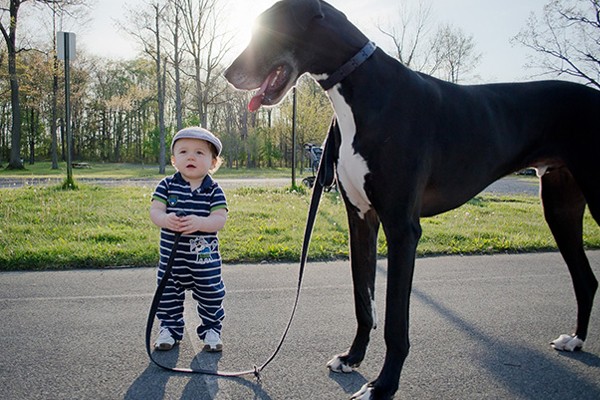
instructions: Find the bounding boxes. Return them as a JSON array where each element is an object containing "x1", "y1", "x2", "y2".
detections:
[{"x1": 225, "y1": 0, "x2": 600, "y2": 399}]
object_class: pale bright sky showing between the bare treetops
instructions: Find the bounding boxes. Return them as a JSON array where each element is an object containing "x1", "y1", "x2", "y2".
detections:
[{"x1": 73, "y1": 0, "x2": 549, "y2": 83}]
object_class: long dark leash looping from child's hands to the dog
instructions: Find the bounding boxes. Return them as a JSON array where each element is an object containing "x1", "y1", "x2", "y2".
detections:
[{"x1": 146, "y1": 119, "x2": 337, "y2": 382}]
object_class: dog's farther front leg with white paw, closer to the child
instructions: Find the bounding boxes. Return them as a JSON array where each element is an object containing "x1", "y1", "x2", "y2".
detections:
[{"x1": 327, "y1": 208, "x2": 379, "y2": 372}]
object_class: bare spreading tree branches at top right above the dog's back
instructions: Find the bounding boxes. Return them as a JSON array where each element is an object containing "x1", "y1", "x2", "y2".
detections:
[{"x1": 513, "y1": 0, "x2": 600, "y2": 89}]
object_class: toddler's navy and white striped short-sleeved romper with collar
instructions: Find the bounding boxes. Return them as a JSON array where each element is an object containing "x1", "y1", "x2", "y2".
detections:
[{"x1": 152, "y1": 172, "x2": 227, "y2": 340}]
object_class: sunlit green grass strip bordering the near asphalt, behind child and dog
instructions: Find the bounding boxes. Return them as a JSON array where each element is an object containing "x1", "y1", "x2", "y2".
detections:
[{"x1": 0, "y1": 183, "x2": 600, "y2": 270}]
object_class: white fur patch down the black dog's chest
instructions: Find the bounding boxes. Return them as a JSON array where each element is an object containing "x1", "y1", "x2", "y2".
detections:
[{"x1": 327, "y1": 85, "x2": 371, "y2": 219}]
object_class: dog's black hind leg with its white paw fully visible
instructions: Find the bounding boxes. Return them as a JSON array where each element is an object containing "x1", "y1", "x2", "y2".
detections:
[{"x1": 541, "y1": 168, "x2": 598, "y2": 351}]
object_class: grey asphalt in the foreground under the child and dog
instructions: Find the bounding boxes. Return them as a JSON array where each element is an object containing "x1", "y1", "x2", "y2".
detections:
[{"x1": 0, "y1": 251, "x2": 600, "y2": 400}]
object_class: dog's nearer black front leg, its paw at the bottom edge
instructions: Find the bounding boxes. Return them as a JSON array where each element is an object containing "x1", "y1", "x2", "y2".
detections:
[{"x1": 352, "y1": 218, "x2": 421, "y2": 400}]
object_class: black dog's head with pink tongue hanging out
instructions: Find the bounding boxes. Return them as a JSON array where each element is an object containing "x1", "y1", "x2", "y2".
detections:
[{"x1": 225, "y1": 0, "x2": 364, "y2": 111}]
